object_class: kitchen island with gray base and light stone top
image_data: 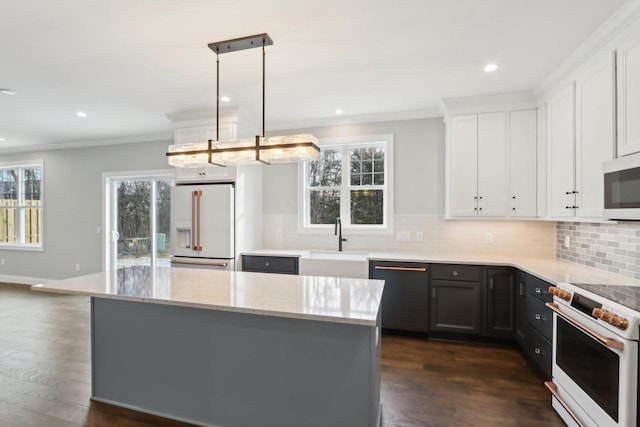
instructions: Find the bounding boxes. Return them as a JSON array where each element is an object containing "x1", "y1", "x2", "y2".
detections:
[{"x1": 33, "y1": 267, "x2": 384, "y2": 427}]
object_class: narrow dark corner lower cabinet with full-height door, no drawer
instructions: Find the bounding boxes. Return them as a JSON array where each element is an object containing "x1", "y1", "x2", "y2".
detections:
[{"x1": 486, "y1": 267, "x2": 516, "y2": 338}]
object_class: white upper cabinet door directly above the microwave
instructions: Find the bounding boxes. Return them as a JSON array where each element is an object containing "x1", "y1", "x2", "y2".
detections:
[{"x1": 617, "y1": 31, "x2": 640, "y2": 157}]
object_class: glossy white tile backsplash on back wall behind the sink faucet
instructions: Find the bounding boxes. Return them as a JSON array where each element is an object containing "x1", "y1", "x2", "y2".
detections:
[{"x1": 263, "y1": 214, "x2": 556, "y2": 258}]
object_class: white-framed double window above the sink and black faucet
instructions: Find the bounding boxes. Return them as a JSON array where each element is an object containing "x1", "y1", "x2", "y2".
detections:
[{"x1": 301, "y1": 135, "x2": 393, "y2": 231}]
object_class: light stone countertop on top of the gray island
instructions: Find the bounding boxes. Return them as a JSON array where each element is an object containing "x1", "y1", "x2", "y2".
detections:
[{"x1": 32, "y1": 267, "x2": 384, "y2": 326}]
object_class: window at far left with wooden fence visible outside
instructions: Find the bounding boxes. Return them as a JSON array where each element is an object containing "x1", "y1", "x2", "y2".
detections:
[{"x1": 0, "y1": 161, "x2": 44, "y2": 250}]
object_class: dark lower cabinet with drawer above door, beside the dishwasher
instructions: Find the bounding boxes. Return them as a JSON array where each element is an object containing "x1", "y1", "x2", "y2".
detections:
[{"x1": 429, "y1": 264, "x2": 483, "y2": 334}]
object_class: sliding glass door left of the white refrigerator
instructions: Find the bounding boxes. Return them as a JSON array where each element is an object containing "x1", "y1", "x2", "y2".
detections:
[{"x1": 105, "y1": 175, "x2": 174, "y2": 270}]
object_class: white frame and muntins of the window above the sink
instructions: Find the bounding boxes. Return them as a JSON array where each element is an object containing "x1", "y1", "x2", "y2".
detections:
[{"x1": 298, "y1": 134, "x2": 394, "y2": 234}]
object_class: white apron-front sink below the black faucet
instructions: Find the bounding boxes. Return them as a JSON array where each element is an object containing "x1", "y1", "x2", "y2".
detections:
[{"x1": 298, "y1": 251, "x2": 369, "y2": 279}]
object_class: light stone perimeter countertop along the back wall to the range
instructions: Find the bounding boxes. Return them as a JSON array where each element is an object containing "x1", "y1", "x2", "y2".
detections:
[{"x1": 244, "y1": 249, "x2": 640, "y2": 286}]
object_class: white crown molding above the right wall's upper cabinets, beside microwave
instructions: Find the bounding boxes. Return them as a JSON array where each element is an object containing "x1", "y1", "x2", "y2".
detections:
[{"x1": 534, "y1": 0, "x2": 640, "y2": 98}]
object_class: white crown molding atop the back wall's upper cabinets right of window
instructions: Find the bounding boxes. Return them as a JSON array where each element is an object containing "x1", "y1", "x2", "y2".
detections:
[{"x1": 439, "y1": 92, "x2": 537, "y2": 116}]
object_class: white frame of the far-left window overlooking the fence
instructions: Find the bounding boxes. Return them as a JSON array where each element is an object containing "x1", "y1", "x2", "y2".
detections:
[{"x1": 0, "y1": 159, "x2": 46, "y2": 252}]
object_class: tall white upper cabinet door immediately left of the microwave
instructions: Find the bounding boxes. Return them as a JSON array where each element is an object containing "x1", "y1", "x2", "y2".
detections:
[{"x1": 575, "y1": 51, "x2": 616, "y2": 218}]
